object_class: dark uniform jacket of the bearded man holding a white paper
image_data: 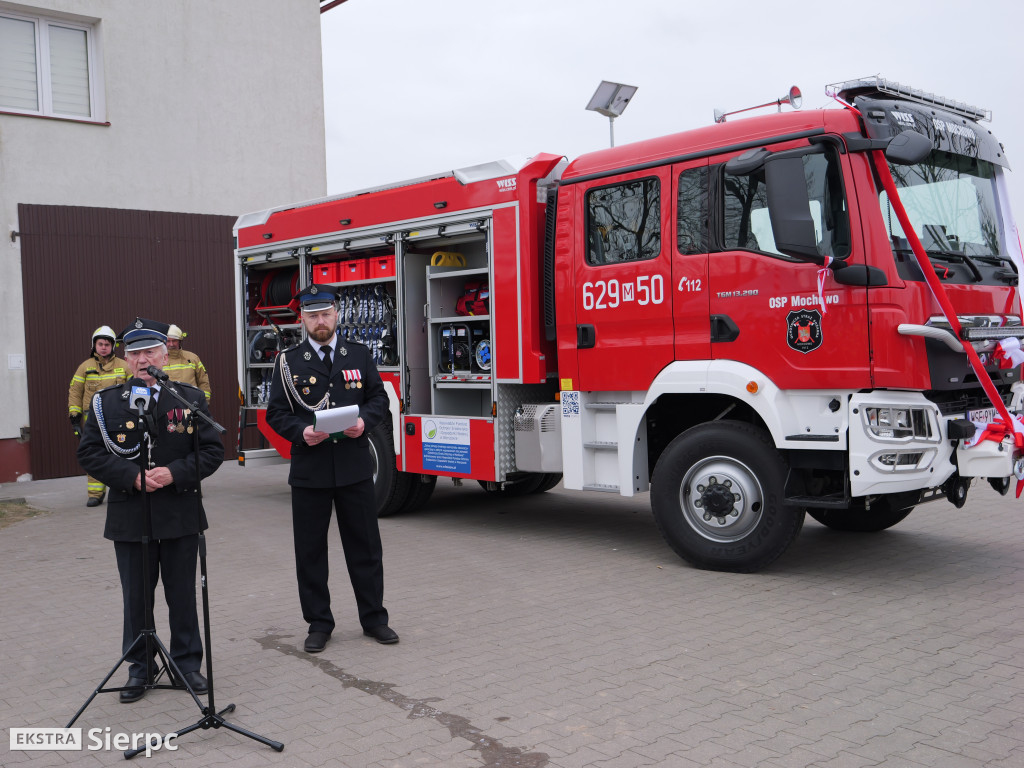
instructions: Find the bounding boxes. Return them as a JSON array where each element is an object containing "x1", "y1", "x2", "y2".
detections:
[{"x1": 266, "y1": 339, "x2": 388, "y2": 488}]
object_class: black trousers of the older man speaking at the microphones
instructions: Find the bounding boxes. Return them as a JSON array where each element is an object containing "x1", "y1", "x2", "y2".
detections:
[{"x1": 114, "y1": 535, "x2": 203, "y2": 678}]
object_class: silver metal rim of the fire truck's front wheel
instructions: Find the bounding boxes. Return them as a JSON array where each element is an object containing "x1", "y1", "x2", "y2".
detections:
[{"x1": 679, "y1": 456, "x2": 764, "y2": 544}]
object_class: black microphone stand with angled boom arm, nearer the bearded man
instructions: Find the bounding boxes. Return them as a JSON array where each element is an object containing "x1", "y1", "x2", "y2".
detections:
[{"x1": 123, "y1": 376, "x2": 285, "y2": 760}]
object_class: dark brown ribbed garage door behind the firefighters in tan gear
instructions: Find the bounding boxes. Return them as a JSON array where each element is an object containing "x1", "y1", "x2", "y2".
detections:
[{"x1": 17, "y1": 205, "x2": 239, "y2": 479}]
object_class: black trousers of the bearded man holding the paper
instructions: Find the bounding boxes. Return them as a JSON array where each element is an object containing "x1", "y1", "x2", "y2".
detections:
[{"x1": 292, "y1": 479, "x2": 388, "y2": 634}]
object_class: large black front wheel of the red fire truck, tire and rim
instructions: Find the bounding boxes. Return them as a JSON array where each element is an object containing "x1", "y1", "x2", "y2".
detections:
[{"x1": 651, "y1": 421, "x2": 804, "y2": 573}]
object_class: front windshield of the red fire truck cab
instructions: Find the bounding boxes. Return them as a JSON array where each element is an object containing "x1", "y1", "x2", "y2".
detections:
[{"x1": 879, "y1": 152, "x2": 1005, "y2": 258}]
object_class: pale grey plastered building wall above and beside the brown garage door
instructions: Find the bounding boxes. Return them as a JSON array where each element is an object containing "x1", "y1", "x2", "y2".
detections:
[{"x1": 0, "y1": 0, "x2": 327, "y2": 439}]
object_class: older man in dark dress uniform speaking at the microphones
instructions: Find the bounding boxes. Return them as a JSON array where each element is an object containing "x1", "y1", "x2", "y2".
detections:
[{"x1": 78, "y1": 318, "x2": 224, "y2": 703}]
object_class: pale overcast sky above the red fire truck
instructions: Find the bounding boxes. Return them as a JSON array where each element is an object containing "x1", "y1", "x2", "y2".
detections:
[{"x1": 322, "y1": 0, "x2": 1024, "y2": 217}]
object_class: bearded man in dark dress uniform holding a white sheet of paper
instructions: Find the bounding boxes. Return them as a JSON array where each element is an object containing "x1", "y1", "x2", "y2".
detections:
[{"x1": 266, "y1": 285, "x2": 398, "y2": 653}]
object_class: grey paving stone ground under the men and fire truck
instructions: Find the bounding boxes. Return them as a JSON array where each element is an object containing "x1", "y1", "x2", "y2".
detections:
[{"x1": 0, "y1": 463, "x2": 1024, "y2": 768}]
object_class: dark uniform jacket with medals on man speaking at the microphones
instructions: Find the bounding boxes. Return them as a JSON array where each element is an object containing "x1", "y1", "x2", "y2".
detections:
[{"x1": 78, "y1": 382, "x2": 224, "y2": 542}]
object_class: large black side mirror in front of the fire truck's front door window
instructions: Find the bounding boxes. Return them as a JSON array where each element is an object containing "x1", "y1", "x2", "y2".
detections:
[{"x1": 765, "y1": 155, "x2": 824, "y2": 264}]
